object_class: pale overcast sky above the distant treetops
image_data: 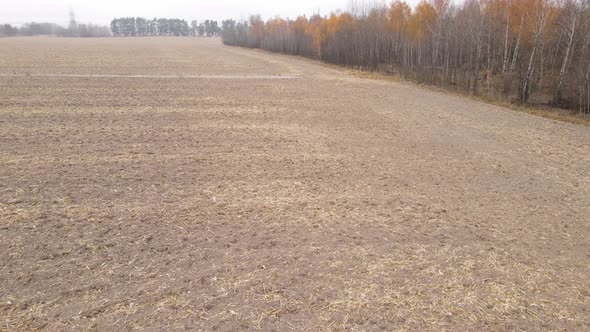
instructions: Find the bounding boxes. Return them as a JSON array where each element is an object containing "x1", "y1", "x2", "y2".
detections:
[{"x1": 0, "y1": 0, "x2": 417, "y2": 25}]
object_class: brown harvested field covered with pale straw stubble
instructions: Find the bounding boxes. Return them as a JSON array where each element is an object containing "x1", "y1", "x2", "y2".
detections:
[{"x1": 0, "y1": 38, "x2": 590, "y2": 331}]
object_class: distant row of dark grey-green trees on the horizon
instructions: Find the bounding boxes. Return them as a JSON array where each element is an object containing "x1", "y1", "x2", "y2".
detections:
[{"x1": 111, "y1": 17, "x2": 221, "y2": 37}]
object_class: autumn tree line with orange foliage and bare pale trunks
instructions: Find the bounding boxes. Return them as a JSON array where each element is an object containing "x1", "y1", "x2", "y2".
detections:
[{"x1": 222, "y1": 0, "x2": 590, "y2": 116}]
